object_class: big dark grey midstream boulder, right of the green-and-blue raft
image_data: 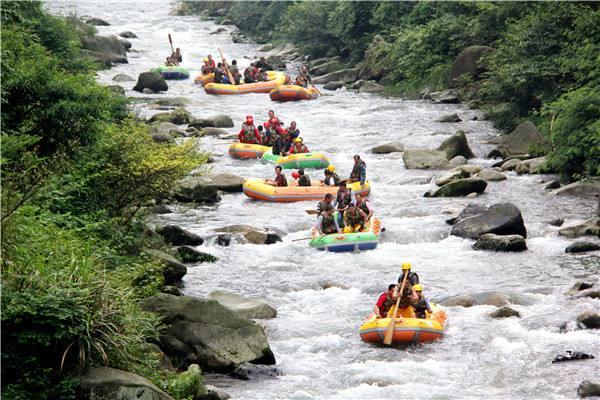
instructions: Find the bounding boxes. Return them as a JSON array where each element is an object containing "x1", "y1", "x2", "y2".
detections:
[{"x1": 451, "y1": 203, "x2": 527, "y2": 239}]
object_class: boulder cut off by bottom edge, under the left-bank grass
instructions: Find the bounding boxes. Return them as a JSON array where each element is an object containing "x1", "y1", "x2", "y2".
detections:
[{"x1": 78, "y1": 367, "x2": 173, "y2": 400}]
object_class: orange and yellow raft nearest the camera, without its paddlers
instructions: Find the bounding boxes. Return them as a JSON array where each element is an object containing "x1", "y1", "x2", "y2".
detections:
[{"x1": 359, "y1": 303, "x2": 448, "y2": 344}]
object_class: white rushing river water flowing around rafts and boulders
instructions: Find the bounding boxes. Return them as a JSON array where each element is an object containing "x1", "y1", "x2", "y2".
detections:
[{"x1": 49, "y1": 2, "x2": 600, "y2": 399}]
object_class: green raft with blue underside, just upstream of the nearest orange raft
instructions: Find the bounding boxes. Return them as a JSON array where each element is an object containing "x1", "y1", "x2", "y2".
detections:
[{"x1": 309, "y1": 217, "x2": 381, "y2": 253}]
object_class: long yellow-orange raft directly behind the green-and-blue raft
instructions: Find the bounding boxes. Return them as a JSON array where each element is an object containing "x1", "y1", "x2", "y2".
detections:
[{"x1": 243, "y1": 178, "x2": 371, "y2": 203}]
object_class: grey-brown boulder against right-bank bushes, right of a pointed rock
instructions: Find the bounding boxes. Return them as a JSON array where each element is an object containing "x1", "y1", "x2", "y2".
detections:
[{"x1": 488, "y1": 121, "x2": 545, "y2": 158}]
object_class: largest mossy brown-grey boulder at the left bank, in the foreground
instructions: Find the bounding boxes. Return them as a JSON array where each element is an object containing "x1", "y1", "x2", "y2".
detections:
[{"x1": 142, "y1": 293, "x2": 275, "y2": 372}]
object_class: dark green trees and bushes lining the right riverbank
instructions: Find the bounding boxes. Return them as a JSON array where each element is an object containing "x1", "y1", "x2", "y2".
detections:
[{"x1": 179, "y1": 0, "x2": 600, "y2": 179}]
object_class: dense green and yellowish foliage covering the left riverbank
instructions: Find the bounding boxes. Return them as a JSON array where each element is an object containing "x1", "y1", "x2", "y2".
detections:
[{"x1": 1, "y1": 2, "x2": 204, "y2": 399}]
